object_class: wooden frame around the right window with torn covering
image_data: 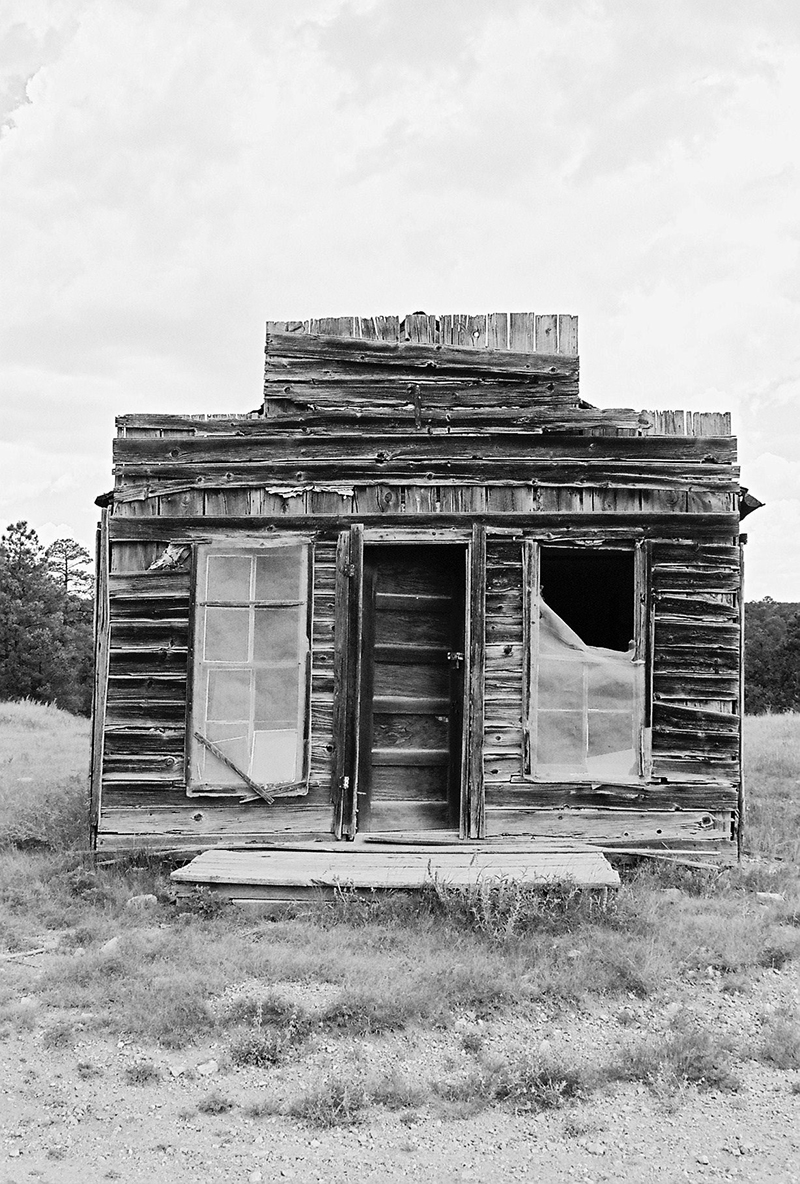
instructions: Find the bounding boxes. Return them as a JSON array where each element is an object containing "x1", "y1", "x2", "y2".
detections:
[{"x1": 522, "y1": 536, "x2": 652, "y2": 785}]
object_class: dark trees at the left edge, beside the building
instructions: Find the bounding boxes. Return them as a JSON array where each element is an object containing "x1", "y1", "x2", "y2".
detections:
[{"x1": 0, "y1": 522, "x2": 92, "y2": 715}]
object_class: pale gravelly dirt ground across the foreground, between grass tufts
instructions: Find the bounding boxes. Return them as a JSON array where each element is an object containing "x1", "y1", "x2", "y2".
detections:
[{"x1": 0, "y1": 937, "x2": 800, "y2": 1184}]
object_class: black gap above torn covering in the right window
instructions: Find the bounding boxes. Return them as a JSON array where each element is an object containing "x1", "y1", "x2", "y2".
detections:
[{"x1": 540, "y1": 546, "x2": 634, "y2": 650}]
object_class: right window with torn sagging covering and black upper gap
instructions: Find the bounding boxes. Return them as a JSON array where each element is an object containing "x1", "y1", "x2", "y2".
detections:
[{"x1": 529, "y1": 546, "x2": 644, "y2": 781}]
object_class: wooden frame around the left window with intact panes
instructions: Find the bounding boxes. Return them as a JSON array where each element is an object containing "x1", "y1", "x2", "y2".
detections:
[{"x1": 185, "y1": 534, "x2": 314, "y2": 800}]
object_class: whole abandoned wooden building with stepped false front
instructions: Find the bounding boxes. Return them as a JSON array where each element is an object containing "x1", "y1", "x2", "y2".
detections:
[{"x1": 92, "y1": 314, "x2": 748, "y2": 885}]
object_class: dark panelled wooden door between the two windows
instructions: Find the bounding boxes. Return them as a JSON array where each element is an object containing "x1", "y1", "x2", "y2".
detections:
[{"x1": 357, "y1": 546, "x2": 466, "y2": 831}]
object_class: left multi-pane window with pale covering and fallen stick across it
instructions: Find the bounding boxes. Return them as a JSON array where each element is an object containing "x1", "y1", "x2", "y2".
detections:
[{"x1": 191, "y1": 543, "x2": 309, "y2": 800}]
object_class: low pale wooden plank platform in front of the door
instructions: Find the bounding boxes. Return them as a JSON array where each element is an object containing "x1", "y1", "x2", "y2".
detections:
[{"x1": 172, "y1": 836, "x2": 619, "y2": 900}]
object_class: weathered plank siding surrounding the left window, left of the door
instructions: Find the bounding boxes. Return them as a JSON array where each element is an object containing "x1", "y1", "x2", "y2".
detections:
[{"x1": 98, "y1": 535, "x2": 336, "y2": 849}]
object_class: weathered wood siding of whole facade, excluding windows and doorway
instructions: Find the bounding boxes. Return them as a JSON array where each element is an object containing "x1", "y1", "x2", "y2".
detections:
[{"x1": 92, "y1": 314, "x2": 741, "y2": 847}]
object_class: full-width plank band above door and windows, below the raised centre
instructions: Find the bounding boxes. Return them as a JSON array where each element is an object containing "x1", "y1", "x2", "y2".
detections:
[{"x1": 114, "y1": 428, "x2": 738, "y2": 526}]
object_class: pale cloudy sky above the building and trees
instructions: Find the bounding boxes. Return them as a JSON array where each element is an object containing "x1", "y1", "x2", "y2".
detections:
[{"x1": 0, "y1": 0, "x2": 800, "y2": 601}]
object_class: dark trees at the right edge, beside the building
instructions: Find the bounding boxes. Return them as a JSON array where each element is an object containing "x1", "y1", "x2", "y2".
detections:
[{"x1": 744, "y1": 597, "x2": 800, "y2": 715}]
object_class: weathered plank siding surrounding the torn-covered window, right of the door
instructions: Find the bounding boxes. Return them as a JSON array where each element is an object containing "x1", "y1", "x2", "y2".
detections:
[{"x1": 484, "y1": 539, "x2": 741, "y2": 845}]
